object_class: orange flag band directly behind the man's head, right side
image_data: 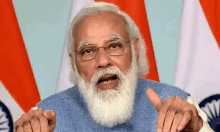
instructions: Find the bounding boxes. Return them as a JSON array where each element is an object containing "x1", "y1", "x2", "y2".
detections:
[{"x1": 95, "y1": 0, "x2": 159, "y2": 81}]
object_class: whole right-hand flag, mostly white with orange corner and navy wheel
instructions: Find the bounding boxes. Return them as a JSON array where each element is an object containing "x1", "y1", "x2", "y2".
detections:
[{"x1": 174, "y1": 0, "x2": 220, "y2": 132}]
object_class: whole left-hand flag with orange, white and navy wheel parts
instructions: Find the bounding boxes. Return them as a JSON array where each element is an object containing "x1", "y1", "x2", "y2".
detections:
[{"x1": 0, "y1": 0, "x2": 40, "y2": 132}]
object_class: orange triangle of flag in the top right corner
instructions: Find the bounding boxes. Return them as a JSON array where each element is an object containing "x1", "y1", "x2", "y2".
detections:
[{"x1": 200, "y1": 0, "x2": 220, "y2": 48}]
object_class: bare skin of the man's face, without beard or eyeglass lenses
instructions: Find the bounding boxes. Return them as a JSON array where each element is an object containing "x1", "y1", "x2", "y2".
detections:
[{"x1": 74, "y1": 13, "x2": 132, "y2": 90}]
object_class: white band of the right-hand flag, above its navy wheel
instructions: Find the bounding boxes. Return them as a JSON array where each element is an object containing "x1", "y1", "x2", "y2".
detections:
[{"x1": 174, "y1": 0, "x2": 220, "y2": 103}]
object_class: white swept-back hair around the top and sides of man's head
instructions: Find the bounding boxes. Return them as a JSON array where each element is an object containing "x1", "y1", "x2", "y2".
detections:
[{"x1": 66, "y1": 2, "x2": 148, "y2": 76}]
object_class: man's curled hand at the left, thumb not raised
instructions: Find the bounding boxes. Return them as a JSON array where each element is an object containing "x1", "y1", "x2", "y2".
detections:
[{"x1": 15, "y1": 109, "x2": 56, "y2": 132}]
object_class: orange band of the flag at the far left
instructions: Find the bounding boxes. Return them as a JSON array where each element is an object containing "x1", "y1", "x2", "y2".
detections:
[{"x1": 0, "y1": 0, "x2": 40, "y2": 112}]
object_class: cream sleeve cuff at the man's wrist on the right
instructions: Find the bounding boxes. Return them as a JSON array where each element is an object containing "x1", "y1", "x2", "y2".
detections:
[{"x1": 187, "y1": 96, "x2": 214, "y2": 132}]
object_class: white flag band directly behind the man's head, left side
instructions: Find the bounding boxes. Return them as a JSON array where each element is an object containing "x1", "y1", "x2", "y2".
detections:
[{"x1": 56, "y1": 0, "x2": 94, "y2": 92}]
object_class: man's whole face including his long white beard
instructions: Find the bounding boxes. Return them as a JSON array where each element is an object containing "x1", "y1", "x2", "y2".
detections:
[{"x1": 70, "y1": 13, "x2": 138, "y2": 127}]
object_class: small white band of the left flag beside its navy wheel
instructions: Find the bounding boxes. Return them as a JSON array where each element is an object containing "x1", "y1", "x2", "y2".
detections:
[{"x1": 0, "y1": 81, "x2": 23, "y2": 122}]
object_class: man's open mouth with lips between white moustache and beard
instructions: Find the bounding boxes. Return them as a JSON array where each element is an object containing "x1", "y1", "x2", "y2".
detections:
[{"x1": 97, "y1": 74, "x2": 119, "y2": 90}]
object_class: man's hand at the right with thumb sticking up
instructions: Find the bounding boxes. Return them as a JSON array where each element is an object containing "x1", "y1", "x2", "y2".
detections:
[{"x1": 146, "y1": 88, "x2": 203, "y2": 132}]
